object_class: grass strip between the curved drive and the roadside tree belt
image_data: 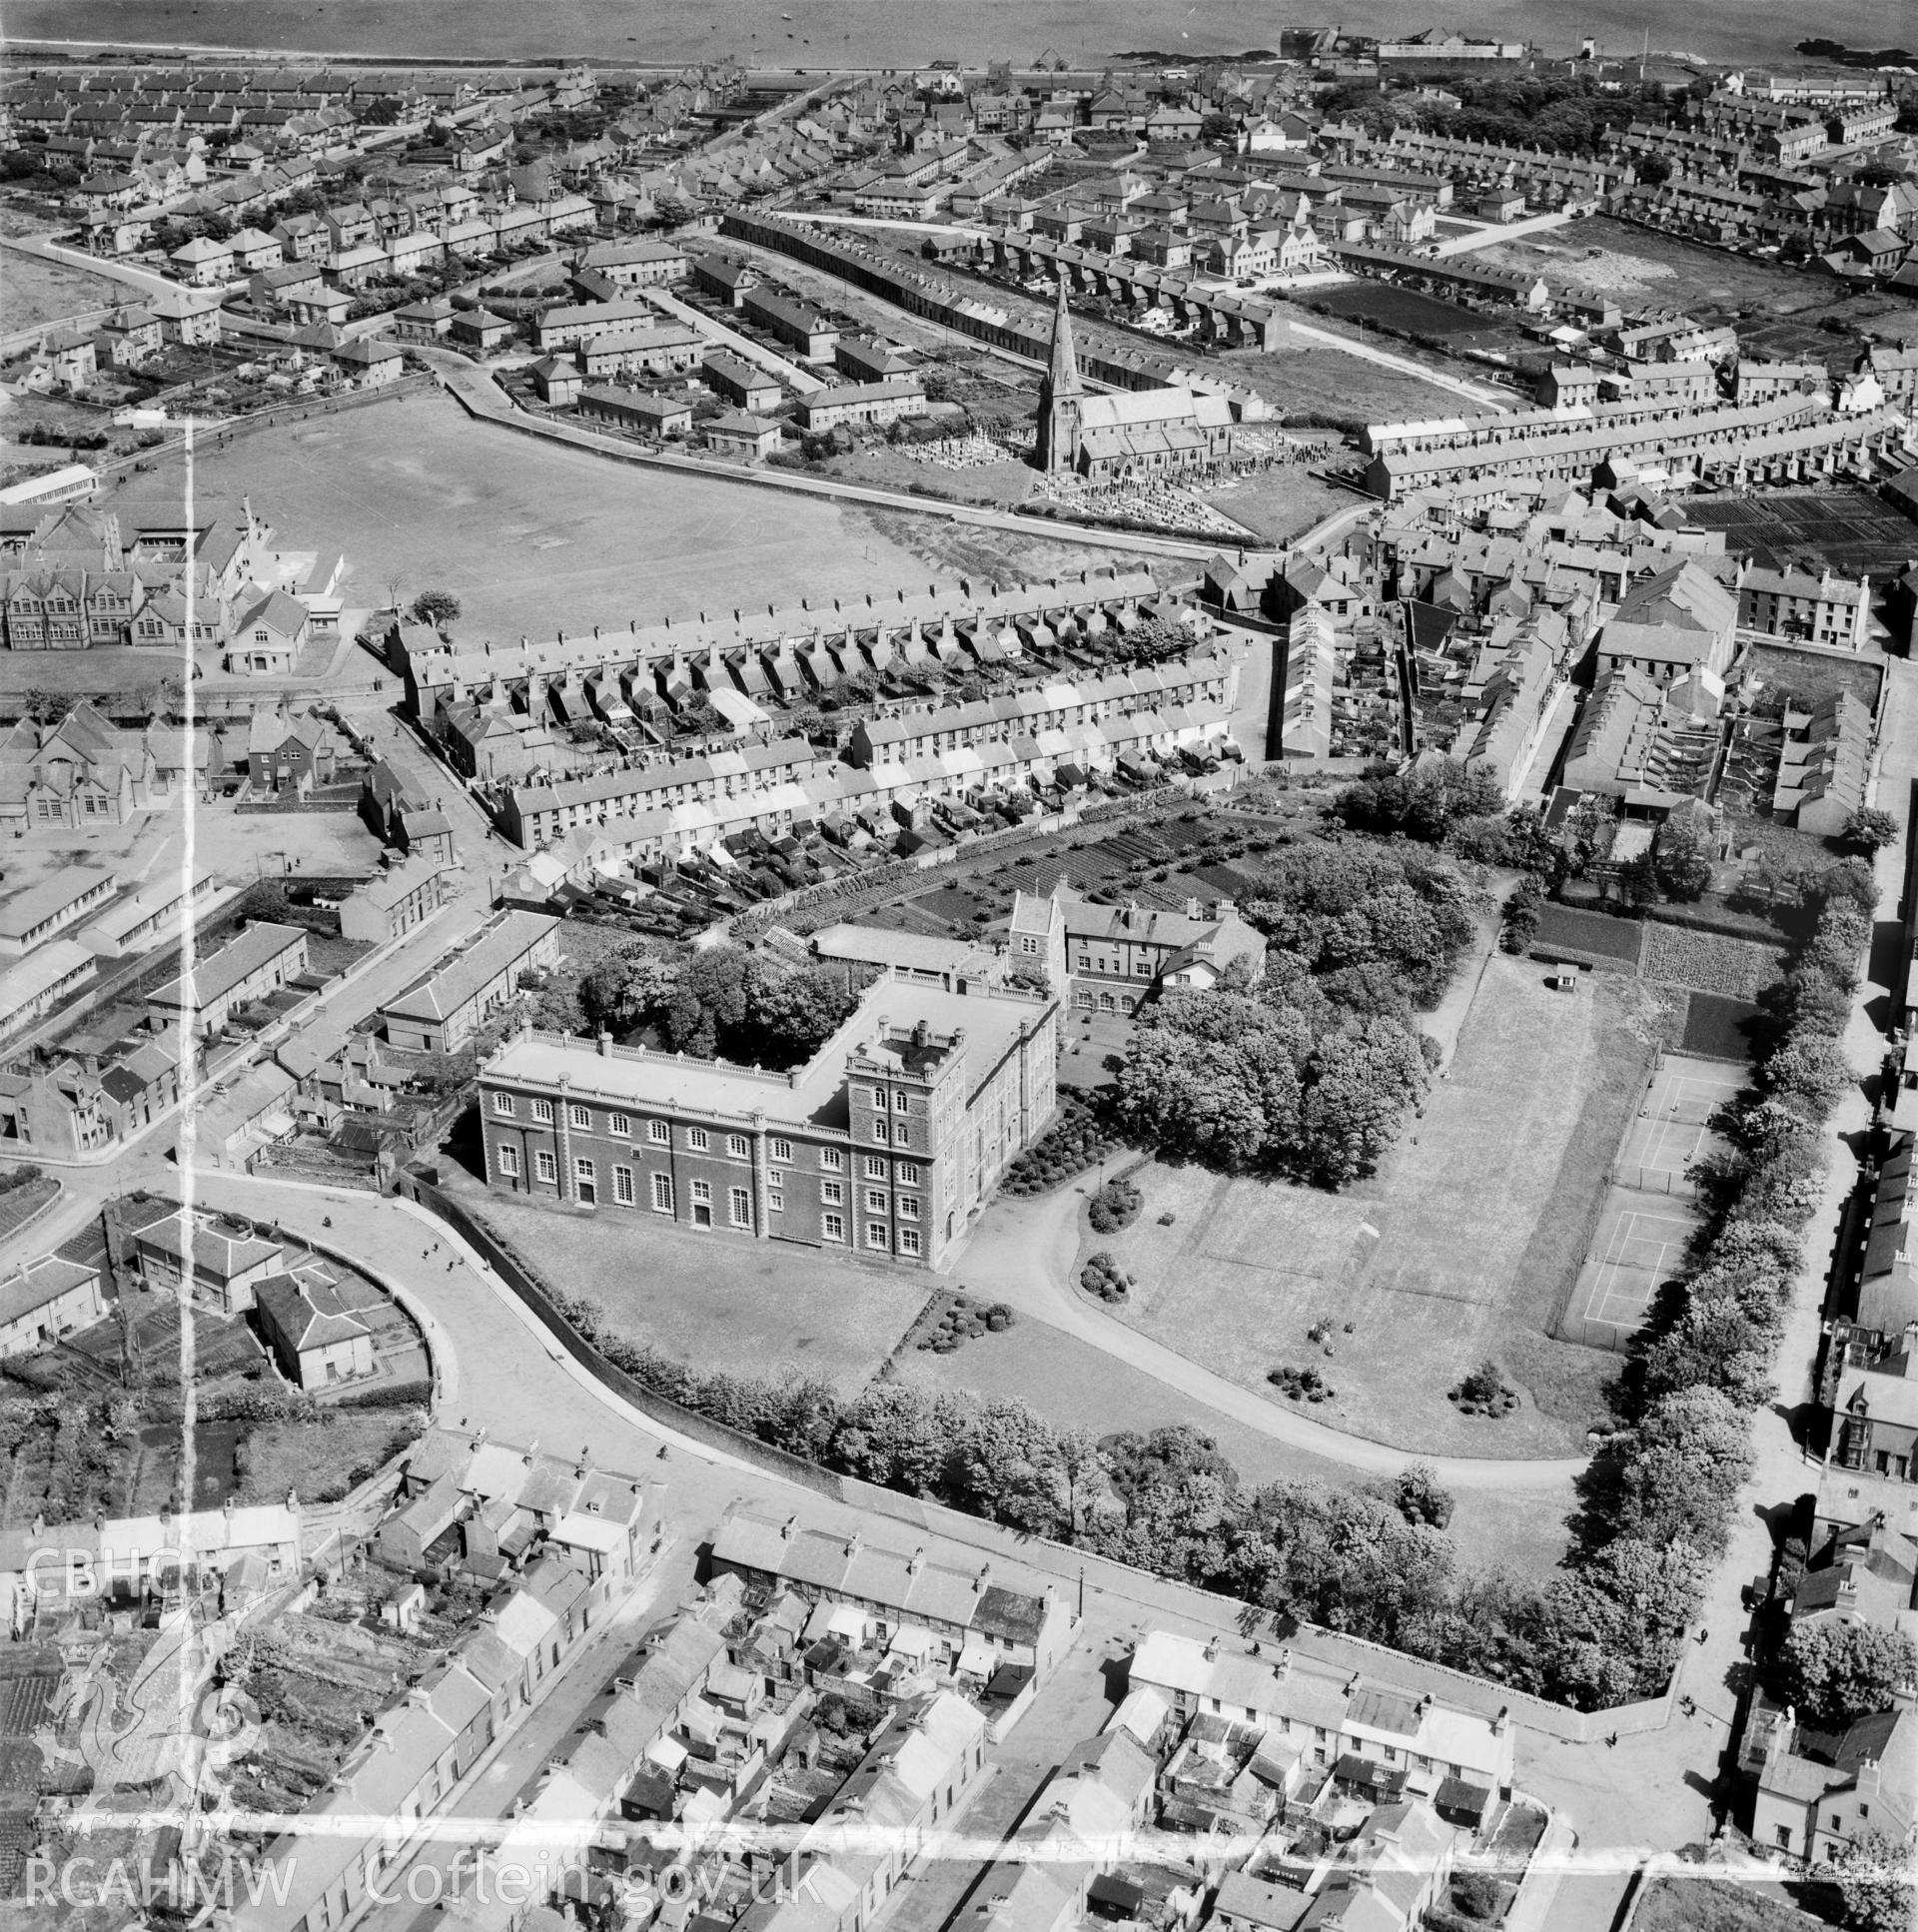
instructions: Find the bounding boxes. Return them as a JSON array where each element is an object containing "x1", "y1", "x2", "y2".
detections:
[{"x1": 894, "y1": 1314, "x2": 1564, "y2": 1576}]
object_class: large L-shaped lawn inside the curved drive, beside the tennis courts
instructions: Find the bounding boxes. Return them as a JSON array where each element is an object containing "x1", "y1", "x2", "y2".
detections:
[{"x1": 1082, "y1": 954, "x2": 1665, "y2": 1456}]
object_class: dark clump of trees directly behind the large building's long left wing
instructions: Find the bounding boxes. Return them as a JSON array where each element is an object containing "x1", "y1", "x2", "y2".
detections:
[{"x1": 579, "y1": 945, "x2": 859, "y2": 1069}]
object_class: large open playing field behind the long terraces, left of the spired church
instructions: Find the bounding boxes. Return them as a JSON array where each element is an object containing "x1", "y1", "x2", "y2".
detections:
[{"x1": 141, "y1": 393, "x2": 1113, "y2": 639}]
